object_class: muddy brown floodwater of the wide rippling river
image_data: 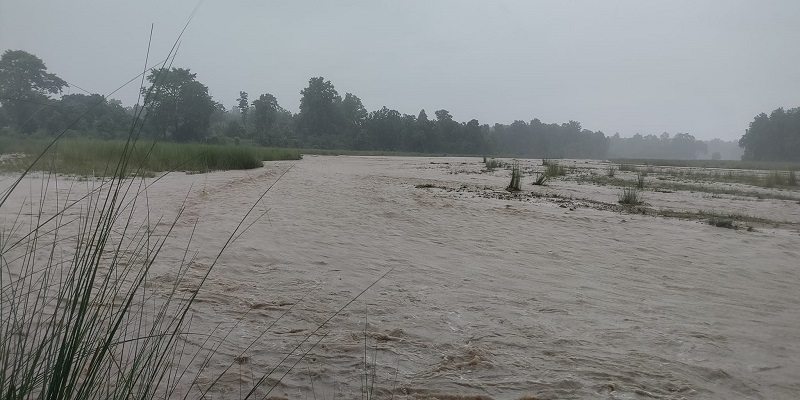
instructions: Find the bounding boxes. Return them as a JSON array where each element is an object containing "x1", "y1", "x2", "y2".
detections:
[{"x1": 0, "y1": 156, "x2": 800, "y2": 399}]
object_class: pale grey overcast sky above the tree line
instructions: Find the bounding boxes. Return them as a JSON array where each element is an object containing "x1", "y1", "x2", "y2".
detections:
[{"x1": 0, "y1": 0, "x2": 800, "y2": 140}]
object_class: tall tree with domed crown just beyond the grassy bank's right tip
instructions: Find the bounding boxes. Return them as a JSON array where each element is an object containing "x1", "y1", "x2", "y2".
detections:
[{"x1": 298, "y1": 77, "x2": 344, "y2": 136}]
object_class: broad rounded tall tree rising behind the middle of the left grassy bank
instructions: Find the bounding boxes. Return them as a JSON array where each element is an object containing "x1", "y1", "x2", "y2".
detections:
[{"x1": 142, "y1": 68, "x2": 217, "y2": 142}]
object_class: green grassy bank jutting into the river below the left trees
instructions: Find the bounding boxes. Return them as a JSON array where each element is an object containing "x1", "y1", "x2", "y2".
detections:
[{"x1": 0, "y1": 136, "x2": 300, "y2": 176}]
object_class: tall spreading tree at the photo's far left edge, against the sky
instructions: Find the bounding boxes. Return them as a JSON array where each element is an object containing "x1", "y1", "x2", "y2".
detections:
[{"x1": 0, "y1": 50, "x2": 68, "y2": 132}]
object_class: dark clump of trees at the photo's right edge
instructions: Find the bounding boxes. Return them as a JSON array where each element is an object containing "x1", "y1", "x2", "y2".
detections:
[{"x1": 739, "y1": 108, "x2": 800, "y2": 161}]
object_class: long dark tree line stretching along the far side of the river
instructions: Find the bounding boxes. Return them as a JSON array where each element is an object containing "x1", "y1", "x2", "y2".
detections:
[{"x1": 0, "y1": 50, "x2": 764, "y2": 159}]
